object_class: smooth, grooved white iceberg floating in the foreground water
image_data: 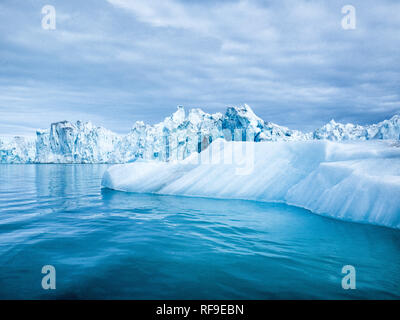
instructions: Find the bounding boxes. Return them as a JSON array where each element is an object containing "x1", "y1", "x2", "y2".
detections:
[{"x1": 102, "y1": 139, "x2": 400, "y2": 228}]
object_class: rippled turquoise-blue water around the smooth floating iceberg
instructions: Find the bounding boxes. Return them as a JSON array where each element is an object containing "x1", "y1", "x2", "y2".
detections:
[{"x1": 0, "y1": 165, "x2": 400, "y2": 299}]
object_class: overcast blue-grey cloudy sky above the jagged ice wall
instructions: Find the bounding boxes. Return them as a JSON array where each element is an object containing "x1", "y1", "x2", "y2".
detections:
[{"x1": 0, "y1": 0, "x2": 400, "y2": 135}]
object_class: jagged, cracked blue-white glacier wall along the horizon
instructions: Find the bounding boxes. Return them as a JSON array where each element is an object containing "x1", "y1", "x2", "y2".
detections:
[{"x1": 0, "y1": 104, "x2": 400, "y2": 163}]
